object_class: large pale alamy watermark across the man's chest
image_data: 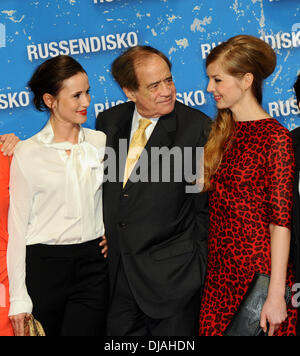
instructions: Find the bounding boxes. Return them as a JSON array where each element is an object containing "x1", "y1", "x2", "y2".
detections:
[{"x1": 99, "y1": 139, "x2": 204, "y2": 193}]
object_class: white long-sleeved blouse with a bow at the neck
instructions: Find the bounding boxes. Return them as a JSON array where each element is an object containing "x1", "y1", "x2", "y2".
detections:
[{"x1": 7, "y1": 121, "x2": 106, "y2": 315}]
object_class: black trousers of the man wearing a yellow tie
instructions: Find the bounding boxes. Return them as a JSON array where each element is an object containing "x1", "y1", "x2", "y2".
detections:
[{"x1": 107, "y1": 262, "x2": 201, "y2": 336}]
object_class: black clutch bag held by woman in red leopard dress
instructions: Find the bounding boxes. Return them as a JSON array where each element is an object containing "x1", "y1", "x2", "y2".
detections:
[{"x1": 224, "y1": 273, "x2": 292, "y2": 336}]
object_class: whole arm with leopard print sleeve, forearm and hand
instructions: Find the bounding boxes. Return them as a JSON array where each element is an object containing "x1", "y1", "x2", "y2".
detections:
[{"x1": 261, "y1": 126, "x2": 295, "y2": 336}]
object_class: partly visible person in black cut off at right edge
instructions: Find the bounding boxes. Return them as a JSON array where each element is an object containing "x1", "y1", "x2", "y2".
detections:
[{"x1": 291, "y1": 74, "x2": 300, "y2": 335}]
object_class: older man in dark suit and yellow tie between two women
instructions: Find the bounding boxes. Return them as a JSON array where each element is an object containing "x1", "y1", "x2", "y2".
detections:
[{"x1": 96, "y1": 46, "x2": 211, "y2": 336}]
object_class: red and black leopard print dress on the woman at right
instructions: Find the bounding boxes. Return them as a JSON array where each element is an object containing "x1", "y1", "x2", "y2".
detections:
[{"x1": 199, "y1": 119, "x2": 297, "y2": 336}]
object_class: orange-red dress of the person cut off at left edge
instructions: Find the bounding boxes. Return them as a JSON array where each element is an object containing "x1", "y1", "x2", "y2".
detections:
[{"x1": 0, "y1": 152, "x2": 14, "y2": 336}]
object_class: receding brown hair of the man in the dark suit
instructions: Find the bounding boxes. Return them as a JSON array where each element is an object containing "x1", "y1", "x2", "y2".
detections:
[{"x1": 112, "y1": 46, "x2": 172, "y2": 90}]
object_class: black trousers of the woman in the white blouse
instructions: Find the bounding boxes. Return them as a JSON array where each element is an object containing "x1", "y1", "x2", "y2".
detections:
[{"x1": 26, "y1": 239, "x2": 108, "y2": 336}]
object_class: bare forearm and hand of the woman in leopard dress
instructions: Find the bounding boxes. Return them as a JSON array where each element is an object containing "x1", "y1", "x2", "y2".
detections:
[{"x1": 260, "y1": 224, "x2": 291, "y2": 336}]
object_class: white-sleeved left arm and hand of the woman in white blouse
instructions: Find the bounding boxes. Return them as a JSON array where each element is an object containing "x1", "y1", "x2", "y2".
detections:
[{"x1": 7, "y1": 152, "x2": 32, "y2": 336}]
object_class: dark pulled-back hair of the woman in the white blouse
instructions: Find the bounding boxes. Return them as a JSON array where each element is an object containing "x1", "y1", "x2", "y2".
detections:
[{"x1": 28, "y1": 56, "x2": 86, "y2": 111}]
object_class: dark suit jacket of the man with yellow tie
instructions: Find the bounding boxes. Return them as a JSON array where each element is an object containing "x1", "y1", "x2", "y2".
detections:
[{"x1": 96, "y1": 102, "x2": 211, "y2": 319}]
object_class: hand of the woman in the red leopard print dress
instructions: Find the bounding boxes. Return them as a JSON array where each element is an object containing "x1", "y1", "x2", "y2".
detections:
[{"x1": 260, "y1": 296, "x2": 288, "y2": 336}]
